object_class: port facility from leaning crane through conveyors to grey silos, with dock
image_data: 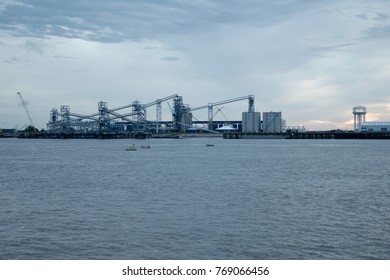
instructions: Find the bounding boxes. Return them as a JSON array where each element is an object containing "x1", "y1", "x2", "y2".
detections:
[{"x1": 18, "y1": 93, "x2": 283, "y2": 138}]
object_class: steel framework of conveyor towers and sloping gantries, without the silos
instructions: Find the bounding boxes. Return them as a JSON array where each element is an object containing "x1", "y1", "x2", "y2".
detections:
[{"x1": 48, "y1": 94, "x2": 255, "y2": 133}]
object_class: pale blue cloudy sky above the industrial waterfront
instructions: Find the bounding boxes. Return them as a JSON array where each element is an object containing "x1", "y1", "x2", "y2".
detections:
[{"x1": 0, "y1": 0, "x2": 390, "y2": 130}]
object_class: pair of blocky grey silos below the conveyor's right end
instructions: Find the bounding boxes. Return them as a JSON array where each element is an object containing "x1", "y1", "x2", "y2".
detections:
[{"x1": 242, "y1": 112, "x2": 283, "y2": 133}]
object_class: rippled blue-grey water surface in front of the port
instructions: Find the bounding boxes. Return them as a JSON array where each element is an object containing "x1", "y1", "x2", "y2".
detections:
[{"x1": 0, "y1": 139, "x2": 390, "y2": 259}]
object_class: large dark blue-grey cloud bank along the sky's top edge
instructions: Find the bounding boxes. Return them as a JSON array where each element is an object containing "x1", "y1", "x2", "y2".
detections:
[{"x1": 0, "y1": 0, "x2": 330, "y2": 41}]
